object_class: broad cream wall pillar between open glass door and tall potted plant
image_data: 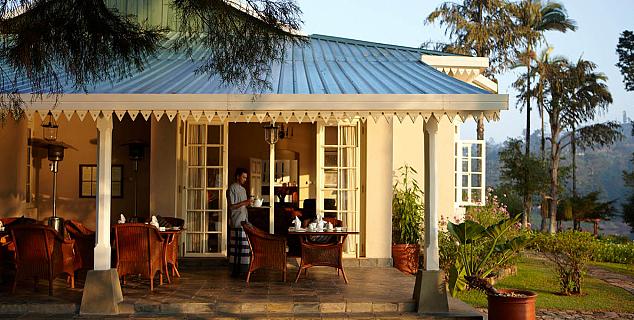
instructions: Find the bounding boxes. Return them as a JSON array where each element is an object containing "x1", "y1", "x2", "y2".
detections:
[{"x1": 365, "y1": 119, "x2": 393, "y2": 259}]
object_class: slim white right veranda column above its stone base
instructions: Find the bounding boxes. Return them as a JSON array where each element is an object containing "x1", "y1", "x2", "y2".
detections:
[{"x1": 424, "y1": 117, "x2": 440, "y2": 271}]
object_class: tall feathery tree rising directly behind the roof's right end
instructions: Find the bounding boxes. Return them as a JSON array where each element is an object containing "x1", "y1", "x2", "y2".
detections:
[{"x1": 425, "y1": 0, "x2": 517, "y2": 140}]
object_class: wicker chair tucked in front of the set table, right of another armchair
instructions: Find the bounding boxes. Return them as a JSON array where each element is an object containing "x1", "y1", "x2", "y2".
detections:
[{"x1": 295, "y1": 218, "x2": 348, "y2": 283}]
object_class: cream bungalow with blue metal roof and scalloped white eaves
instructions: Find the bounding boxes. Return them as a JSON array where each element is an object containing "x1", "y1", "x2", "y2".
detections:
[{"x1": 0, "y1": 0, "x2": 508, "y2": 316}]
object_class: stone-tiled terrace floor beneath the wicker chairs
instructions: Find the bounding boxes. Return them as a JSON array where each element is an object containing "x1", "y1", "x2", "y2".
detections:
[{"x1": 0, "y1": 260, "x2": 481, "y2": 319}]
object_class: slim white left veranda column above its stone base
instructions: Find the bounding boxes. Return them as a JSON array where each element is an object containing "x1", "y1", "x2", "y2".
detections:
[{"x1": 95, "y1": 115, "x2": 112, "y2": 270}]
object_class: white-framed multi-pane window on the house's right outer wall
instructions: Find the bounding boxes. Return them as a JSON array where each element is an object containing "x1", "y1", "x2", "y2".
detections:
[{"x1": 455, "y1": 140, "x2": 486, "y2": 206}]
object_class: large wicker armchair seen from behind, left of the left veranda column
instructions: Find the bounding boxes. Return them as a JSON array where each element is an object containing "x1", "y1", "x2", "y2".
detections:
[{"x1": 11, "y1": 224, "x2": 77, "y2": 295}]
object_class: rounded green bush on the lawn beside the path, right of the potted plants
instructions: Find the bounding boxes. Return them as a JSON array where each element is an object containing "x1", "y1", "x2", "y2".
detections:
[{"x1": 536, "y1": 230, "x2": 596, "y2": 295}]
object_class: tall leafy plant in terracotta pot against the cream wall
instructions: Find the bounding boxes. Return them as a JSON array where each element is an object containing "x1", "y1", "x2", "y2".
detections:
[{"x1": 392, "y1": 165, "x2": 424, "y2": 274}]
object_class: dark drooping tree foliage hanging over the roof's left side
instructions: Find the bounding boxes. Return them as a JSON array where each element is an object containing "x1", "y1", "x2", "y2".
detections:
[{"x1": 0, "y1": 0, "x2": 302, "y2": 117}]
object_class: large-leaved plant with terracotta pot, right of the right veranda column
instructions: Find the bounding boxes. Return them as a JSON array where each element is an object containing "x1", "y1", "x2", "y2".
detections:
[{"x1": 447, "y1": 215, "x2": 537, "y2": 320}]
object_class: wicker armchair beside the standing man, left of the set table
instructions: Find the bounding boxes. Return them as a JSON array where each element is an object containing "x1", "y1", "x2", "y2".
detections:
[{"x1": 242, "y1": 221, "x2": 286, "y2": 283}]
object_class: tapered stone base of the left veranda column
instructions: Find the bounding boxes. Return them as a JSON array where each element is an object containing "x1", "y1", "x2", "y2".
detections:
[{"x1": 79, "y1": 269, "x2": 123, "y2": 315}]
